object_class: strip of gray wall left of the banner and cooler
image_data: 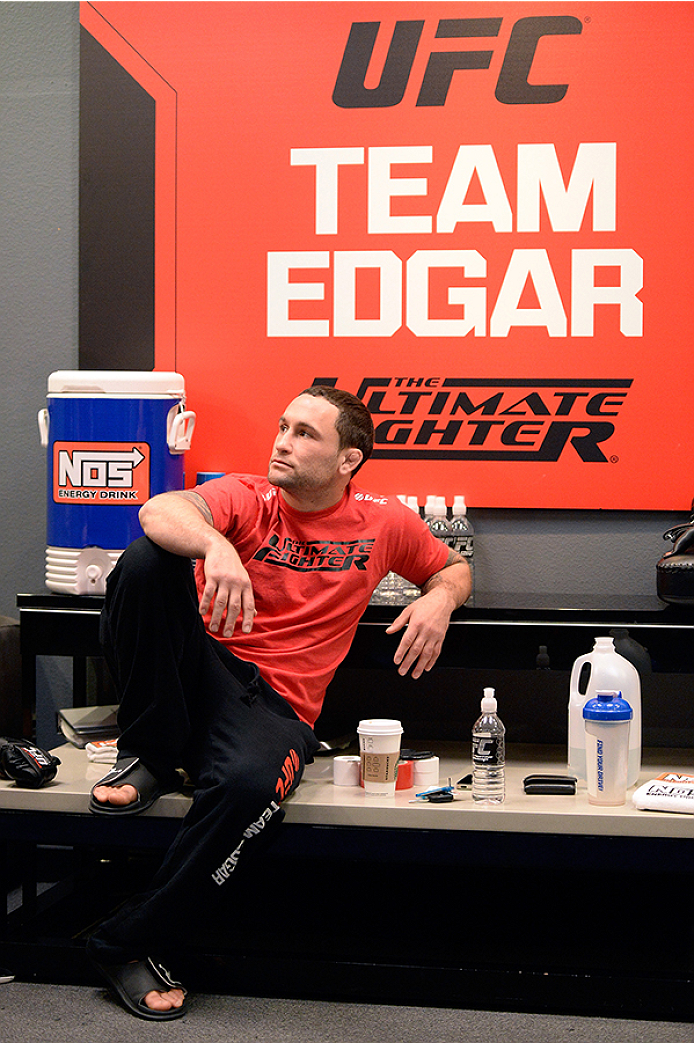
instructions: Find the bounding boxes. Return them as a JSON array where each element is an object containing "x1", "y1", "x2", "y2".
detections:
[{"x1": 0, "y1": 0, "x2": 79, "y2": 615}]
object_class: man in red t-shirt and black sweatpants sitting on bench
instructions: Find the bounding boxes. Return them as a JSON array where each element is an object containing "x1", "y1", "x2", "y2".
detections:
[{"x1": 88, "y1": 387, "x2": 471, "y2": 1020}]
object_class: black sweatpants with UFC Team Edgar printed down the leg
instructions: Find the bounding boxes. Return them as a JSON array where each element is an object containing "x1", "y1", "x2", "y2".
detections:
[{"x1": 90, "y1": 537, "x2": 318, "y2": 963}]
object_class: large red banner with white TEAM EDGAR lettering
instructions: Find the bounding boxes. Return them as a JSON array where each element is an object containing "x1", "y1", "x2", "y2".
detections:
[{"x1": 81, "y1": 0, "x2": 694, "y2": 510}]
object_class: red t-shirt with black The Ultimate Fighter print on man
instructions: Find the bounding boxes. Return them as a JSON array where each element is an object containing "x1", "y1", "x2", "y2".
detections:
[{"x1": 195, "y1": 475, "x2": 448, "y2": 725}]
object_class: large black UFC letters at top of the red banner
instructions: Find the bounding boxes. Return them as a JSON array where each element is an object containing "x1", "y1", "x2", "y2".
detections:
[{"x1": 333, "y1": 15, "x2": 582, "y2": 108}]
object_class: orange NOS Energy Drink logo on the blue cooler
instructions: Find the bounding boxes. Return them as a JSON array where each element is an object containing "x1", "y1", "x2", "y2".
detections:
[{"x1": 53, "y1": 442, "x2": 150, "y2": 507}]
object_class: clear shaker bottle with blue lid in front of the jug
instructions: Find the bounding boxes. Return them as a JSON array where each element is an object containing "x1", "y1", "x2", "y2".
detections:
[{"x1": 583, "y1": 692, "x2": 633, "y2": 807}]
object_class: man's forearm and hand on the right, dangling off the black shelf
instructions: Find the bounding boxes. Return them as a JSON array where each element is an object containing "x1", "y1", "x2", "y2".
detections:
[{"x1": 386, "y1": 552, "x2": 471, "y2": 678}]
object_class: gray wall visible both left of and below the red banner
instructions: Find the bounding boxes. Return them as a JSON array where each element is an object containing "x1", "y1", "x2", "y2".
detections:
[{"x1": 0, "y1": 0, "x2": 686, "y2": 614}]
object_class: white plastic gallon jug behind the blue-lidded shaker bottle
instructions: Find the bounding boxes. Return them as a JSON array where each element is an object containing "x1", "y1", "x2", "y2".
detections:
[{"x1": 569, "y1": 637, "x2": 641, "y2": 786}]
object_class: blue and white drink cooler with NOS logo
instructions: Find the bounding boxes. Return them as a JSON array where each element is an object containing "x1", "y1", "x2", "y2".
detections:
[{"x1": 39, "y1": 370, "x2": 195, "y2": 595}]
